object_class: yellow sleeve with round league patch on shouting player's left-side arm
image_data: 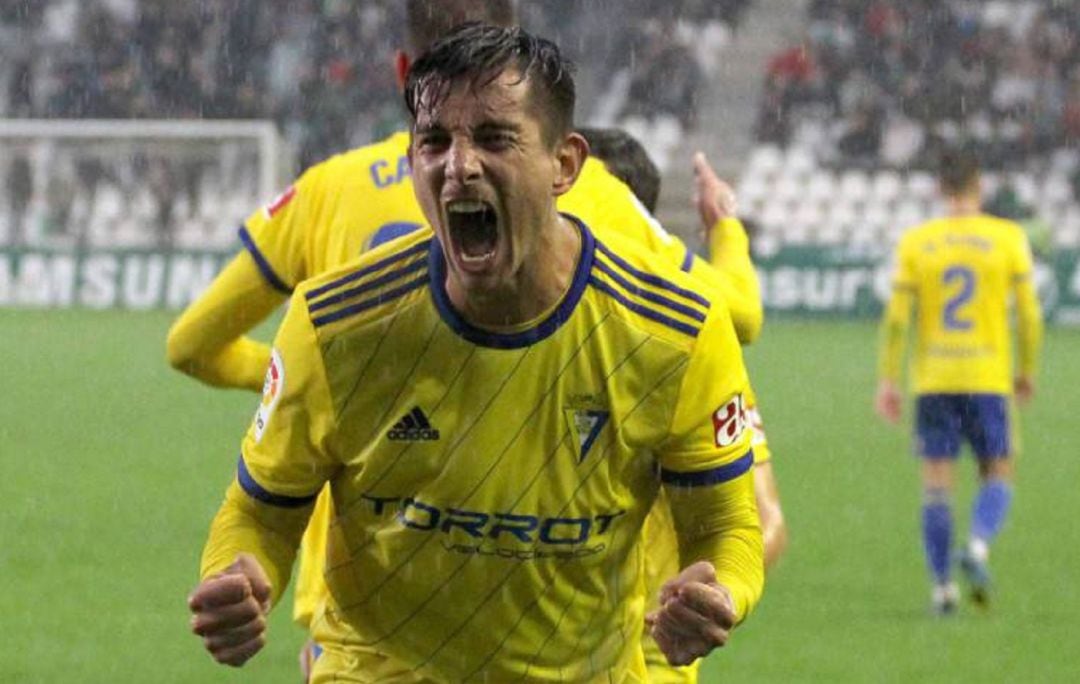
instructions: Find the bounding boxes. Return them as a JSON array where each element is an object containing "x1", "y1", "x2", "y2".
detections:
[{"x1": 201, "y1": 296, "x2": 338, "y2": 600}]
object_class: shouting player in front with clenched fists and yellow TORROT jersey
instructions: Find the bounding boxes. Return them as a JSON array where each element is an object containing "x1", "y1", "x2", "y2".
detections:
[{"x1": 191, "y1": 26, "x2": 761, "y2": 682}]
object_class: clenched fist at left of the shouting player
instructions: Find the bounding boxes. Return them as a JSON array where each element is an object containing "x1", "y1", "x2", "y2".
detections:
[{"x1": 188, "y1": 553, "x2": 270, "y2": 668}]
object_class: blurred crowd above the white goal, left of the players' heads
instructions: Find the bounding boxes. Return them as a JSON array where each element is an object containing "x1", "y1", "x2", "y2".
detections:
[{"x1": 0, "y1": 0, "x2": 400, "y2": 165}]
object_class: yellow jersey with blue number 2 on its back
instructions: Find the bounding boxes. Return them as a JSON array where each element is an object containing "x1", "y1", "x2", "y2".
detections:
[{"x1": 879, "y1": 214, "x2": 1042, "y2": 394}]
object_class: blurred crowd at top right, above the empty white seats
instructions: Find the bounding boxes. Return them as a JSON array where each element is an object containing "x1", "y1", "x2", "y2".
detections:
[{"x1": 756, "y1": 0, "x2": 1080, "y2": 169}]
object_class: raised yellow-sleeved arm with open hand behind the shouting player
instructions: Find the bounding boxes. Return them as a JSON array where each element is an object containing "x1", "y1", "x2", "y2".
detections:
[{"x1": 691, "y1": 152, "x2": 765, "y2": 345}]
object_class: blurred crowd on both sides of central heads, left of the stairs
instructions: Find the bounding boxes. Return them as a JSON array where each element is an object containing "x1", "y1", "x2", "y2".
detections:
[{"x1": 0, "y1": 0, "x2": 746, "y2": 167}]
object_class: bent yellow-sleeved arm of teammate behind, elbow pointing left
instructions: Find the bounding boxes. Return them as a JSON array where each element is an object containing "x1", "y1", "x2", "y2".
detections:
[{"x1": 165, "y1": 252, "x2": 286, "y2": 391}]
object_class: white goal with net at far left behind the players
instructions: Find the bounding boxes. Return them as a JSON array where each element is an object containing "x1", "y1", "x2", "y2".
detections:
[{"x1": 0, "y1": 120, "x2": 282, "y2": 250}]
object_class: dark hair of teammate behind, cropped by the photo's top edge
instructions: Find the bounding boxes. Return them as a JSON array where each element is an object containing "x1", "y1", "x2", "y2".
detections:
[{"x1": 405, "y1": 0, "x2": 517, "y2": 56}]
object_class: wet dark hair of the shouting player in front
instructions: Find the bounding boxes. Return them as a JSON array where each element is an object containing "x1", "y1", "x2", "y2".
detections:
[{"x1": 405, "y1": 23, "x2": 576, "y2": 145}]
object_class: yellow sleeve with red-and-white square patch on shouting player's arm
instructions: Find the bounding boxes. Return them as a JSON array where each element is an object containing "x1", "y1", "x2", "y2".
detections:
[{"x1": 660, "y1": 303, "x2": 765, "y2": 620}]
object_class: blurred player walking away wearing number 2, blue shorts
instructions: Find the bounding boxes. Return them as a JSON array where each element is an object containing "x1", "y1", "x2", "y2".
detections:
[{"x1": 876, "y1": 152, "x2": 1042, "y2": 614}]
